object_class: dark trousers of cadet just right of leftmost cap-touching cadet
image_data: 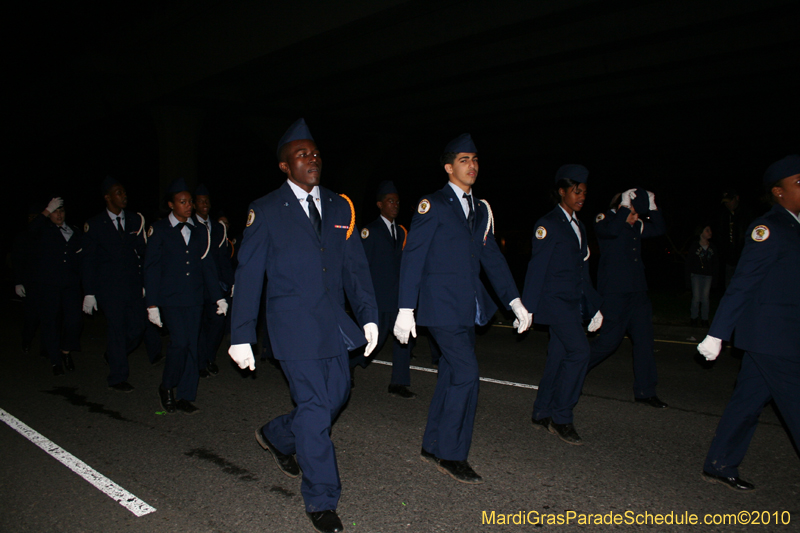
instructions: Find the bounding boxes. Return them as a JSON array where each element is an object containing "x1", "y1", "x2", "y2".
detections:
[{"x1": 97, "y1": 294, "x2": 161, "y2": 385}]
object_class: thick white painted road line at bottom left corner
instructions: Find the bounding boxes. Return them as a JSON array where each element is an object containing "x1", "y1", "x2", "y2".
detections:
[{"x1": 0, "y1": 409, "x2": 156, "y2": 517}]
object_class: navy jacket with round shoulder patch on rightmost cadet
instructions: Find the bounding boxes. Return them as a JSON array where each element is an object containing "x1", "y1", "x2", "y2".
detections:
[{"x1": 708, "y1": 205, "x2": 800, "y2": 361}]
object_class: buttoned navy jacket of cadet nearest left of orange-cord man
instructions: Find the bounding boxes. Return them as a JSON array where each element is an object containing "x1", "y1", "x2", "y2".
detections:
[{"x1": 144, "y1": 218, "x2": 222, "y2": 307}]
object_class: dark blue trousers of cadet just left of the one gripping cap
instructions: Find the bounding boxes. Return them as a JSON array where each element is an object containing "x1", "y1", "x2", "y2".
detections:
[{"x1": 532, "y1": 313, "x2": 589, "y2": 424}]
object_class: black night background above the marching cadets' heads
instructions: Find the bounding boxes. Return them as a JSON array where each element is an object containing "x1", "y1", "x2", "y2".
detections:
[{"x1": 3, "y1": 0, "x2": 800, "y2": 288}]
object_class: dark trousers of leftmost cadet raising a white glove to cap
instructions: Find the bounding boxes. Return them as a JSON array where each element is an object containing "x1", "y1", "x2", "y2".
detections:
[{"x1": 36, "y1": 284, "x2": 83, "y2": 365}]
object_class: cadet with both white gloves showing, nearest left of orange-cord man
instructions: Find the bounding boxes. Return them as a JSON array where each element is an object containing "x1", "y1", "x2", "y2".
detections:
[{"x1": 144, "y1": 178, "x2": 228, "y2": 415}]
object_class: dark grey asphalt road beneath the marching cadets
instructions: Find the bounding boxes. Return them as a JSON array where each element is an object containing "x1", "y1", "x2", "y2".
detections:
[{"x1": 0, "y1": 302, "x2": 800, "y2": 533}]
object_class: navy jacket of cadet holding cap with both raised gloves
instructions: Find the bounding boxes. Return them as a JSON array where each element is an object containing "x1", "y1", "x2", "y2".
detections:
[{"x1": 594, "y1": 207, "x2": 666, "y2": 294}]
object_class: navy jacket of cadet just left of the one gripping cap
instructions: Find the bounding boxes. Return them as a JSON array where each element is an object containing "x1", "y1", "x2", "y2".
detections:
[{"x1": 522, "y1": 206, "x2": 603, "y2": 324}]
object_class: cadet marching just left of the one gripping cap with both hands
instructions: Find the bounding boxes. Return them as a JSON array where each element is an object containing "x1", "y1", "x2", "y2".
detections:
[{"x1": 522, "y1": 165, "x2": 603, "y2": 445}]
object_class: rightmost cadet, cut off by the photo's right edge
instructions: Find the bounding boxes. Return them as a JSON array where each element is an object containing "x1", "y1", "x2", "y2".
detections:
[{"x1": 697, "y1": 155, "x2": 800, "y2": 491}]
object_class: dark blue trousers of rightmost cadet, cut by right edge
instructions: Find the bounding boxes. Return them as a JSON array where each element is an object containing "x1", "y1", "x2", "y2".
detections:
[{"x1": 703, "y1": 352, "x2": 800, "y2": 477}]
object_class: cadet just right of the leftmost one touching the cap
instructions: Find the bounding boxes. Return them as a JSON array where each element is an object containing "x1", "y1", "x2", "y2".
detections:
[{"x1": 83, "y1": 176, "x2": 162, "y2": 392}]
